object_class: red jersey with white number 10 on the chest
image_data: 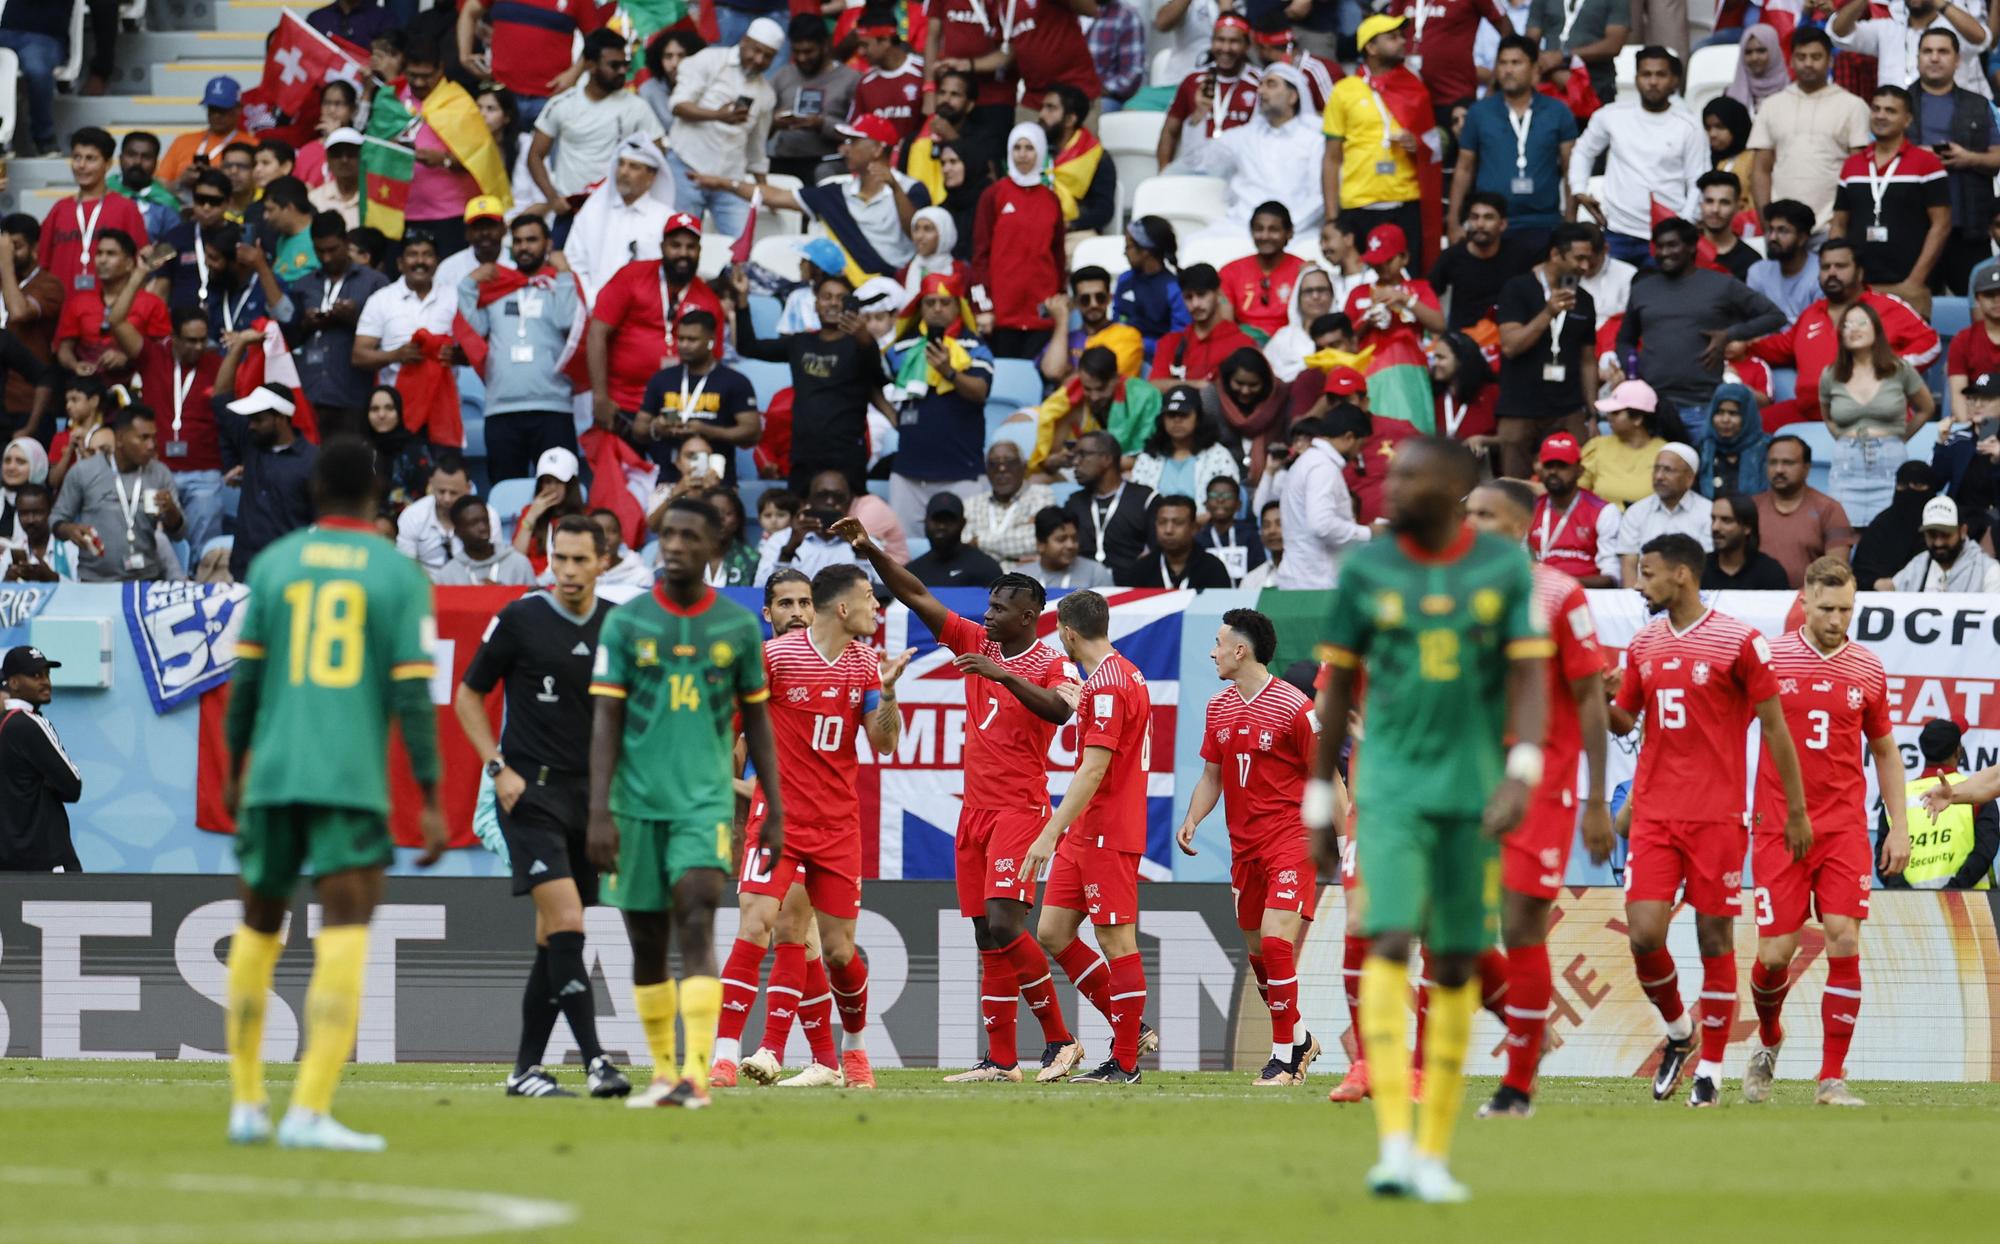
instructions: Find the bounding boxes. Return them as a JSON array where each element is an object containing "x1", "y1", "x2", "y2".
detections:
[{"x1": 764, "y1": 628, "x2": 882, "y2": 848}]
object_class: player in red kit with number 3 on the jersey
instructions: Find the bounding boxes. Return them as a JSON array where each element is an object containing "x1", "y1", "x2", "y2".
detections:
[{"x1": 1744, "y1": 558, "x2": 1910, "y2": 1106}]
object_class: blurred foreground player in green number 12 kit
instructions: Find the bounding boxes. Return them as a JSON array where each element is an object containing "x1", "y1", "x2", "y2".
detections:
[{"x1": 1302, "y1": 436, "x2": 1552, "y2": 1202}]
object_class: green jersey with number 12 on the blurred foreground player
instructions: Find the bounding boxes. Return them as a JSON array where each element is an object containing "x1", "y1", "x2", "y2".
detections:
[{"x1": 1320, "y1": 528, "x2": 1554, "y2": 816}]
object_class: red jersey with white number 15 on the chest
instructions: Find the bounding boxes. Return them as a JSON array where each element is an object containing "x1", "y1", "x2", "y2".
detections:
[{"x1": 1618, "y1": 610, "x2": 1778, "y2": 822}]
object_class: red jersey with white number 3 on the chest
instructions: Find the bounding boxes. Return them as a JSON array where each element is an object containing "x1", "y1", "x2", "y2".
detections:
[{"x1": 1756, "y1": 630, "x2": 1890, "y2": 838}]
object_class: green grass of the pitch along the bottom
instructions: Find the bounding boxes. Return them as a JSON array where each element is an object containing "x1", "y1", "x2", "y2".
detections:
[{"x1": 0, "y1": 1056, "x2": 2000, "y2": 1244}]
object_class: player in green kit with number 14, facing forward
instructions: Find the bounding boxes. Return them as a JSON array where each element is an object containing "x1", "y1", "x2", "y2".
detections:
[{"x1": 586, "y1": 496, "x2": 784, "y2": 1110}]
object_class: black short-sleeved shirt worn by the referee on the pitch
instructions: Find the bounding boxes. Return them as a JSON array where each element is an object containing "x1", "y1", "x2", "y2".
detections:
[{"x1": 466, "y1": 592, "x2": 612, "y2": 780}]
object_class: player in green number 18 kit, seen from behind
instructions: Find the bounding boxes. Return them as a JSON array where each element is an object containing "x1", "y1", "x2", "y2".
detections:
[{"x1": 224, "y1": 440, "x2": 444, "y2": 1152}]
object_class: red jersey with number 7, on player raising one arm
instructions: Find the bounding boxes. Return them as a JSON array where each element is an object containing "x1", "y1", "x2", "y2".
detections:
[{"x1": 938, "y1": 614, "x2": 1070, "y2": 810}]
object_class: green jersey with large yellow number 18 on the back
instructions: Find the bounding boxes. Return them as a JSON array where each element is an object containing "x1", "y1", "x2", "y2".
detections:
[{"x1": 228, "y1": 520, "x2": 438, "y2": 816}]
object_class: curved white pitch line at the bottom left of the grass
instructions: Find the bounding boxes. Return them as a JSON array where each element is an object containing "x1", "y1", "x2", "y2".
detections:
[{"x1": 0, "y1": 1166, "x2": 576, "y2": 1244}]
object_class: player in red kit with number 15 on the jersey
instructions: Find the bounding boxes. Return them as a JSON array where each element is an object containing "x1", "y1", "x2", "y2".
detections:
[{"x1": 1610, "y1": 534, "x2": 1812, "y2": 1106}]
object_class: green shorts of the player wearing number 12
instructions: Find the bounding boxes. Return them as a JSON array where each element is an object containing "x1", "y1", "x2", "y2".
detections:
[{"x1": 1354, "y1": 808, "x2": 1500, "y2": 954}]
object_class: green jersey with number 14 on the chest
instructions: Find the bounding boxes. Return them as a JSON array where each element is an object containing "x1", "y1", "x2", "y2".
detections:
[{"x1": 590, "y1": 586, "x2": 770, "y2": 824}]
